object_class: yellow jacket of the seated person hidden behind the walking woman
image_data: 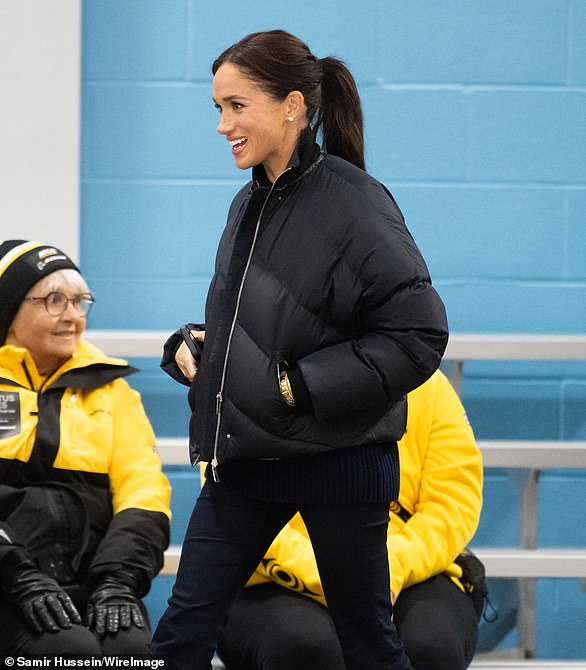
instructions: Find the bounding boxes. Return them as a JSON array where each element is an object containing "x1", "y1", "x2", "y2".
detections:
[{"x1": 247, "y1": 371, "x2": 482, "y2": 604}]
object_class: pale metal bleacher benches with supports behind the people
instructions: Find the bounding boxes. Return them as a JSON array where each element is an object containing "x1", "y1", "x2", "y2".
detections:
[{"x1": 87, "y1": 330, "x2": 586, "y2": 670}]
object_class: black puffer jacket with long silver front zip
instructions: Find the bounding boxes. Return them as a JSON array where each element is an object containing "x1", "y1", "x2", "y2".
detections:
[{"x1": 180, "y1": 130, "x2": 447, "y2": 472}]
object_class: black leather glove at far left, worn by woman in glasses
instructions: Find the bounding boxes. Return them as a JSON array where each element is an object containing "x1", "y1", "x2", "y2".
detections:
[{"x1": 3, "y1": 567, "x2": 81, "y2": 633}]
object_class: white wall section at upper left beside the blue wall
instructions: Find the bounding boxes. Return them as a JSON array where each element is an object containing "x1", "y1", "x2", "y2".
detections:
[{"x1": 0, "y1": 0, "x2": 81, "y2": 260}]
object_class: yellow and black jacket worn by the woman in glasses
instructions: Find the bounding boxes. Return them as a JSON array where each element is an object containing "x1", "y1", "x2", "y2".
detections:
[{"x1": 0, "y1": 340, "x2": 171, "y2": 588}]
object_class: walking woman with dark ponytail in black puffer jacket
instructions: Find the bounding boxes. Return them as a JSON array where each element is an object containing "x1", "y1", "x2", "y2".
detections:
[{"x1": 153, "y1": 31, "x2": 447, "y2": 670}]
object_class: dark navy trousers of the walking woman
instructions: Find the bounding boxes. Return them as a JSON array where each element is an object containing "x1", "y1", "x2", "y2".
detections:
[{"x1": 152, "y1": 481, "x2": 412, "y2": 670}]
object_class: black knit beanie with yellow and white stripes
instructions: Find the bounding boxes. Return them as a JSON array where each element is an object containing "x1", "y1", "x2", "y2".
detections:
[{"x1": 0, "y1": 240, "x2": 79, "y2": 346}]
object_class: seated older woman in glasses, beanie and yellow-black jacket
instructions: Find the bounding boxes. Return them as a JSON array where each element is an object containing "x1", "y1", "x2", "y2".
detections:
[{"x1": 0, "y1": 240, "x2": 170, "y2": 657}]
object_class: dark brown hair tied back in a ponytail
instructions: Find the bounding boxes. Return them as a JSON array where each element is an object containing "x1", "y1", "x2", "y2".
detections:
[{"x1": 212, "y1": 30, "x2": 365, "y2": 170}]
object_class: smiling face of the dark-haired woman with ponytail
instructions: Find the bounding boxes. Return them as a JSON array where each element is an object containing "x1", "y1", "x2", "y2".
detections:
[{"x1": 213, "y1": 63, "x2": 303, "y2": 181}]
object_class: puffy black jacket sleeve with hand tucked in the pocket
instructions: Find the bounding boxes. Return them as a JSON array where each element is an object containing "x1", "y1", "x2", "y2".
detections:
[{"x1": 298, "y1": 190, "x2": 448, "y2": 420}]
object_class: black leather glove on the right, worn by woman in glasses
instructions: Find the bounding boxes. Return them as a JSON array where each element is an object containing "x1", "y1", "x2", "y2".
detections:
[{"x1": 87, "y1": 577, "x2": 144, "y2": 635}]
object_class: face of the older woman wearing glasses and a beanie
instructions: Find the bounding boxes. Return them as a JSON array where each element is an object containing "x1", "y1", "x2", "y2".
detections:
[{"x1": 5, "y1": 270, "x2": 89, "y2": 376}]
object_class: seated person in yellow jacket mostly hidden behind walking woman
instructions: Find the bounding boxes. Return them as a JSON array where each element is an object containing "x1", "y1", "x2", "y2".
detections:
[{"x1": 218, "y1": 371, "x2": 482, "y2": 670}]
